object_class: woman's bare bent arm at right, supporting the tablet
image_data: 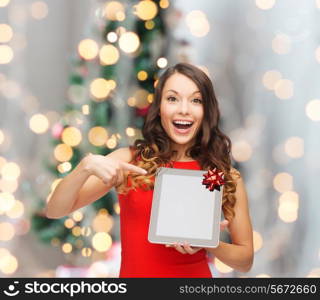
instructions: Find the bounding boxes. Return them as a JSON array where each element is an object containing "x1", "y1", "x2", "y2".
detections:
[{"x1": 206, "y1": 171, "x2": 253, "y2": 272}]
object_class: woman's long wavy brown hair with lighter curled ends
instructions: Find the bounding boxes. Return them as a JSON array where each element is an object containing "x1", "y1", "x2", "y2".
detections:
[{"x1": 118, "y1": 63, "x2": 240, "y2": 221}]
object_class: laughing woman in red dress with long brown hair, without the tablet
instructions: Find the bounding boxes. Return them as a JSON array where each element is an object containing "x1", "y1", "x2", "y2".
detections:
[{"x1": 47, "y1": 63, "x2": 253, "y2": 277}]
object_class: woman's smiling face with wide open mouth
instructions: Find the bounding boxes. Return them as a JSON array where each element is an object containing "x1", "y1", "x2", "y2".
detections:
[{"x1": 160, "y1": 73, "x2": 203, "y2": 150}]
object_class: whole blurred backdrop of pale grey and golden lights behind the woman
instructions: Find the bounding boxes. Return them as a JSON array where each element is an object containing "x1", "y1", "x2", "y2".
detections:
[{"x1": 0, "y1": 0, "x2": 320, "y2": 277}]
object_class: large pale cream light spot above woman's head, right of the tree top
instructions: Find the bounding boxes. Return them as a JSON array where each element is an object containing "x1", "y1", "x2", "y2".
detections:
[{"x1": 186, "y1": 10, "x2": 210, "y2": 37}]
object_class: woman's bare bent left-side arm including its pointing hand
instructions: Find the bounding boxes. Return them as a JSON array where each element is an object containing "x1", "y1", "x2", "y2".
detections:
[{"x1": 46, "y1": 148, "x2": 143, "y2": 218}]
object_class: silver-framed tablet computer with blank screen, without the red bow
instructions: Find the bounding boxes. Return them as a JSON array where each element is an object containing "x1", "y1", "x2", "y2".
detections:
[{"x1": 148, "y1": 167, "x2": 223, "y2": 248}]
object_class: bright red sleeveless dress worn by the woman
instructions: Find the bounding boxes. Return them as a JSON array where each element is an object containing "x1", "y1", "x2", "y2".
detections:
[{"x1": 118, "y1": 161, "x2": 212, "y2": 278}]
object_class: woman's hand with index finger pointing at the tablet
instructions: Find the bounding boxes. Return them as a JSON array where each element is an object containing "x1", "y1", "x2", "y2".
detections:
[{"x1": 82, "y1": 153, "x2": 148, "y2": 186}]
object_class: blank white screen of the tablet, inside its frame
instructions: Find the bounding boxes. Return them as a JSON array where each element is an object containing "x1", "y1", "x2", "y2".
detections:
[{"x1": 156, "y1": 174, "x2": 215, "y2": 239}]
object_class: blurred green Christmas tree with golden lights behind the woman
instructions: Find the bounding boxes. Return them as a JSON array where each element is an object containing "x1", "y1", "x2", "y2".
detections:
[{"x1": 32, "y1": 0, "x2": 169, "y2": 264}]
